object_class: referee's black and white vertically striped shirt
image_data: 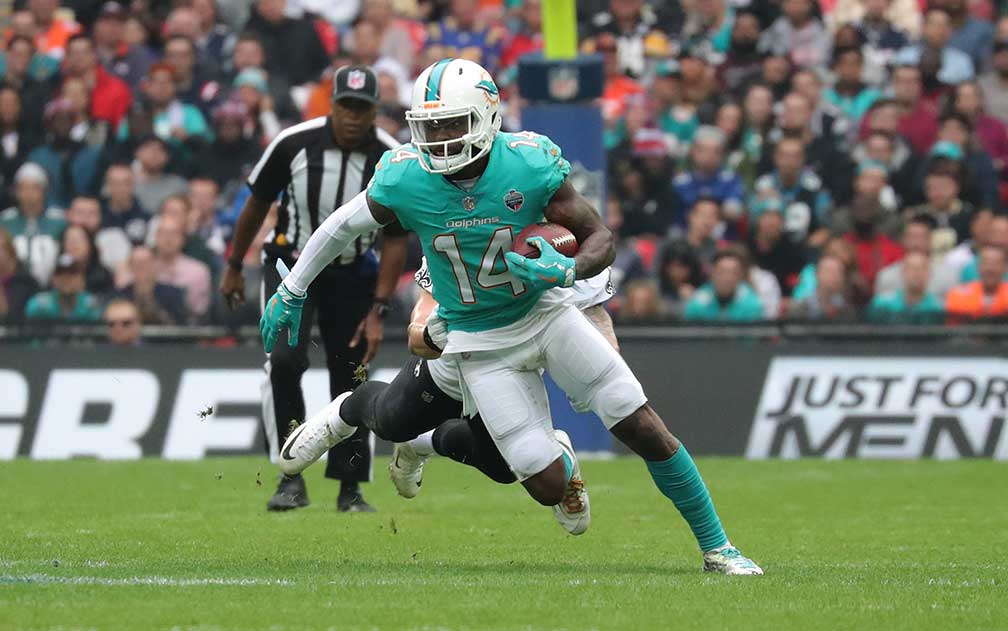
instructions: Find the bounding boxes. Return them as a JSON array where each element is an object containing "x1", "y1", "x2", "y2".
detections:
[{"x1": 248, "y1": 116, "x2": 401, "y2": 265}]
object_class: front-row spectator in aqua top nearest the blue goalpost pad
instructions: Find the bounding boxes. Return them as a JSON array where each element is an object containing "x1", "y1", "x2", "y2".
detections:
[{"x1": 682, "y1": 251, "x2": 763, "y2": 322}]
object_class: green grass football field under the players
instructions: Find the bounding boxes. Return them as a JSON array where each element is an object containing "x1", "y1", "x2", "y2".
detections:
[{"x1": 0, "y1": 459, "x2": 1008, "y2": 631}]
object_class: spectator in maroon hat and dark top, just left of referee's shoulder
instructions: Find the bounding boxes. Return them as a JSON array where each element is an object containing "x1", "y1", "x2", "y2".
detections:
[{"x1": 196, "y1": 101, "x2": 261, "y2": 192}]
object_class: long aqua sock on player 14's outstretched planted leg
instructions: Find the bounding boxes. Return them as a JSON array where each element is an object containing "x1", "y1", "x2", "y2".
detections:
[{"x1": 646, "y1": 444, "x2": 728, "y2": 551}]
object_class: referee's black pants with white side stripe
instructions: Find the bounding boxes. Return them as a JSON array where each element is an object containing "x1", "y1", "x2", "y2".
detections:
[{"x1": 262, "y1": 257, "x2": 375, "y2": 482}]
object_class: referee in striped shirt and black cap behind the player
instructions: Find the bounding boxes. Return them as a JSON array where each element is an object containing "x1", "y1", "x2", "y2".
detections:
[{"x1": 221, "y1": 66, "x2": 407, "y2": 512}]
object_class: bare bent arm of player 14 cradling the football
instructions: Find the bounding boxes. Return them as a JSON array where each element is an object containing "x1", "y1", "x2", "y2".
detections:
[{"x1": 543, "y1": 181, "x2": 616, "y2": 278}]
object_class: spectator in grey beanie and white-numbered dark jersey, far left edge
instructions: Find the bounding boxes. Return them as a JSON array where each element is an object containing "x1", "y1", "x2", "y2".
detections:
[{"x1": 0, "y1": 162, "x2": 66, "y2": 285}]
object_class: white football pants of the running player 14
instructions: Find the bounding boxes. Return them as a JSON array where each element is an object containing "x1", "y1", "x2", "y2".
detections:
[{"x1": 443, "y1": 306, "x2": 647, "y2": 480}]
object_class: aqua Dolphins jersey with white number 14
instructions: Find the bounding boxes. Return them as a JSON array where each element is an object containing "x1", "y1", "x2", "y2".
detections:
[{"x1": 368, "y1": 132, "x2": 571, "y2": 332}]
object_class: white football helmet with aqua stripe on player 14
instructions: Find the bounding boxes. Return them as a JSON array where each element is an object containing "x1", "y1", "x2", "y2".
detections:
[{"x1": 406, "y1": 58, "x2": 501, "y2": 174}]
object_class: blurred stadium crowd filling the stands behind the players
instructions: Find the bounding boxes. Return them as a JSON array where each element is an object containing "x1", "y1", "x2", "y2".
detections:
[{"x1": 0, "y1": 0, "x2": 1008, "y2": 334}]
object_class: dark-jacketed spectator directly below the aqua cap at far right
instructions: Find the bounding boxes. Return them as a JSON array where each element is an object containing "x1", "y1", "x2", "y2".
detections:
[{"x1": 905, "y1": 157, "x2": 975, "y2": 255}]
